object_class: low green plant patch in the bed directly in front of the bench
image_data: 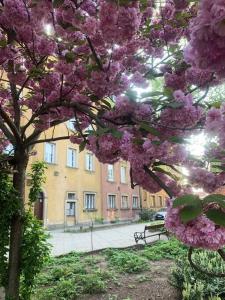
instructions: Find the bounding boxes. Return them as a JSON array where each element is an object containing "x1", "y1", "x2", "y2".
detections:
[{"x1": 142, "y1": 239, "x2": 187, "y2": 260}]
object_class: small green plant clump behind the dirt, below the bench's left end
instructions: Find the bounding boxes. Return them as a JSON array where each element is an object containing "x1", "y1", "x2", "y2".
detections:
[{"x1": 104, "y1": 249, "x2": 148, "y2": 273}]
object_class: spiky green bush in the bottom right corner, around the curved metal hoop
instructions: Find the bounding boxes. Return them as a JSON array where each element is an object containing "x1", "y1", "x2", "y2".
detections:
[{"x1": 171, "y1": 250, "x2": 225, "y2": 300}]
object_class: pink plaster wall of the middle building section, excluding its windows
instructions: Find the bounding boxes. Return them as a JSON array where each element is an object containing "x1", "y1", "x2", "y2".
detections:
[{"x1": 101, "y1": 161, "x2": 140, "y2": 221}]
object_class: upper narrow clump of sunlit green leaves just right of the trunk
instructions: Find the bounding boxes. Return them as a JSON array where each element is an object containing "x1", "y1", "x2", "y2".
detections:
[{"x1": 28, "y1": 161, "x2": 47, "y2": 203}]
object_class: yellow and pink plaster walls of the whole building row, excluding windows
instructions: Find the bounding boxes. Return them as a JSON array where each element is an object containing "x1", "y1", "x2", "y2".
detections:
[{"x1": 26, "y1": 124, "x2": 166, "y2": 228}]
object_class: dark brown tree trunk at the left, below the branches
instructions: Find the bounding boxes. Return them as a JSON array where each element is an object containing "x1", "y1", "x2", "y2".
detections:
[{"x1": 6, "y1": 152, "x2": 28, "y2": 300}]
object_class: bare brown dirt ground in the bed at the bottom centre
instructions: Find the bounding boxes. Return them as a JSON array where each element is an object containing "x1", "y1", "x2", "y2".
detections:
[{"x1": 78, "y1": 260, "x2": 181, "y2": 300}]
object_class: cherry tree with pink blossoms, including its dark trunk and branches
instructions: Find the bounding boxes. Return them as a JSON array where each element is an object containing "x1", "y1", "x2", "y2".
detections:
[{"x1": 0, "y1": 0, "x2": 225, "y2": 299}]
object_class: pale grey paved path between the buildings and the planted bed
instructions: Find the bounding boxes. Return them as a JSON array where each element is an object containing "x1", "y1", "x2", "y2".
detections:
[{"x1": 50, "y1": 223, "x2": 164, "y2": 256}]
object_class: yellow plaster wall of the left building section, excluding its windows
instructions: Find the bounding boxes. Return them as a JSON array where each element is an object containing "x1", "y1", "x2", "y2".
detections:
[{"x1": 27, "y1": 124, "x2": 102, "y2": 227}]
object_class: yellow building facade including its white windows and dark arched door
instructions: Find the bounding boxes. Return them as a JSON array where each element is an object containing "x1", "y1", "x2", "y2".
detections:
[{"x1": 27, "y1": 123, "x2": 102, "y2": 228}]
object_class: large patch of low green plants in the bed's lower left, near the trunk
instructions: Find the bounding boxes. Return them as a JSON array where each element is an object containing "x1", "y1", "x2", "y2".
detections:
[{"x1": 34, "y1": 253, "x2": 115, "y2": 300}]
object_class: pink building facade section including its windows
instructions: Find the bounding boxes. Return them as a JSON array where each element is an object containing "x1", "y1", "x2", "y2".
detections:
[{"x1": 101, "y1": 161, "x2": 141, "y2": 222}]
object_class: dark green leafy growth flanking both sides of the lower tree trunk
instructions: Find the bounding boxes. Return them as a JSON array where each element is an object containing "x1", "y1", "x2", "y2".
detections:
[{"x1": 0, "y1": 165, "x2": 50, "y2": 300}]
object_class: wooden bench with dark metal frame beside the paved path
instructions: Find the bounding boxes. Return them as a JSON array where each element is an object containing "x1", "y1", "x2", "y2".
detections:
[{"x1": 134, "y1": 223, "x2": 168, "y2": 244}]
